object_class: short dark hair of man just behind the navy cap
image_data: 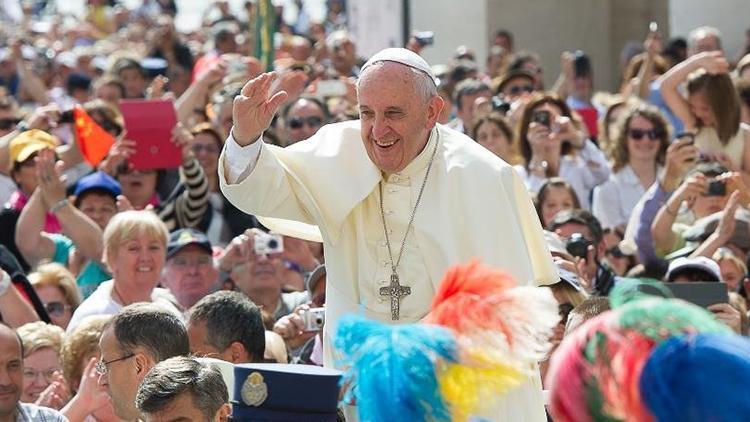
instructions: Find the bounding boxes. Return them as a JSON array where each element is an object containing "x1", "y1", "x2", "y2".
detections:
[{"x1": 188, "y1": 290, "x2": 266, "y2": 362}]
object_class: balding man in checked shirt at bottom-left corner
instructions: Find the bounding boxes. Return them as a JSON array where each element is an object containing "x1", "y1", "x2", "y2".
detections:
[{"x1": 0, "y1": 324, "x2": 67, "y2": 422}]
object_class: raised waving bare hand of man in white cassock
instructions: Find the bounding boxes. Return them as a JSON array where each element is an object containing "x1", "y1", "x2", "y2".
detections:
[{"x1": 232, "y1": 72, "x2": 287, "y2": 146}]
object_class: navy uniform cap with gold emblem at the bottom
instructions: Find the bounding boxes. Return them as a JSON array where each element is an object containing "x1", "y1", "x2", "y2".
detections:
[{"x1": 230, "y1": 363, "x2": 342, "y2": 422}]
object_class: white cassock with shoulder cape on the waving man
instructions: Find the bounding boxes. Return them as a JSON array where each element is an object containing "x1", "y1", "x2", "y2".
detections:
[{"x1": 219, "y1": 121, "x2": 558, "y2": 421}]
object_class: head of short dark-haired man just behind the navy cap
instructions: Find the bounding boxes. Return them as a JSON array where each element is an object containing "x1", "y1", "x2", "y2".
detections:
[{"x1": 187, "y1": 291, "x2": 266, "y2": 363}]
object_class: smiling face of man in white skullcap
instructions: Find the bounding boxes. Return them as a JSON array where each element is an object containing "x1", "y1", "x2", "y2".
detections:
[{"x1": 357, "y1": 62, "x2": 443, "y2": 174}]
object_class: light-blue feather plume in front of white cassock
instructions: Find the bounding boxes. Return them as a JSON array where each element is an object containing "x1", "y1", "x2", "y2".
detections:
[{"x1": 335, "y1": 315, "x2": 457, "y2": 422}]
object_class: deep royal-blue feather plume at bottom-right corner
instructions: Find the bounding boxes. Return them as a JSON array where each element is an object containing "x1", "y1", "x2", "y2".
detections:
[{"x1": 640, "y1": 334, "x2": 750, "y2": 422}]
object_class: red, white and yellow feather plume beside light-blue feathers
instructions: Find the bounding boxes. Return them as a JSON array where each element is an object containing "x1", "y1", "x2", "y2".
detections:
[{"x1": 424, "y1": 261, "x2": 560, "y2": 420}]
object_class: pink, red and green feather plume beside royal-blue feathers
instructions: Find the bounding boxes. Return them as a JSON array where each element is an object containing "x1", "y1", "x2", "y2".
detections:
[{"x1": 547, "y1": 297, "x2": 731, "y2": 422}]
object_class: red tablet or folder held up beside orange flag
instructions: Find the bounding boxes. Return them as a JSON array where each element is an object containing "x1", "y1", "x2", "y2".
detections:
[{"x1": 120, "y1": 100, "x2": 182, "y2": 170}]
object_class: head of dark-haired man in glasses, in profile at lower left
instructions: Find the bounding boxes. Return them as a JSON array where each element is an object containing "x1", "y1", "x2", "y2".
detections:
[{"x1": 96, "y1": 303, "x2": 190, "y2": 420}]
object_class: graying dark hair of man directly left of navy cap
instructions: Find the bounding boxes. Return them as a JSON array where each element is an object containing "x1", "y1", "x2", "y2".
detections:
[{"x1": 135, "y1": 356, "x2": 229, "y2": 421}]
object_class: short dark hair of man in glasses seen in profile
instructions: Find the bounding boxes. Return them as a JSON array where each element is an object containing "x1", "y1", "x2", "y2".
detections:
[{"x1": 103, "y1": 303, "x2": 190, "y2": 362}]
